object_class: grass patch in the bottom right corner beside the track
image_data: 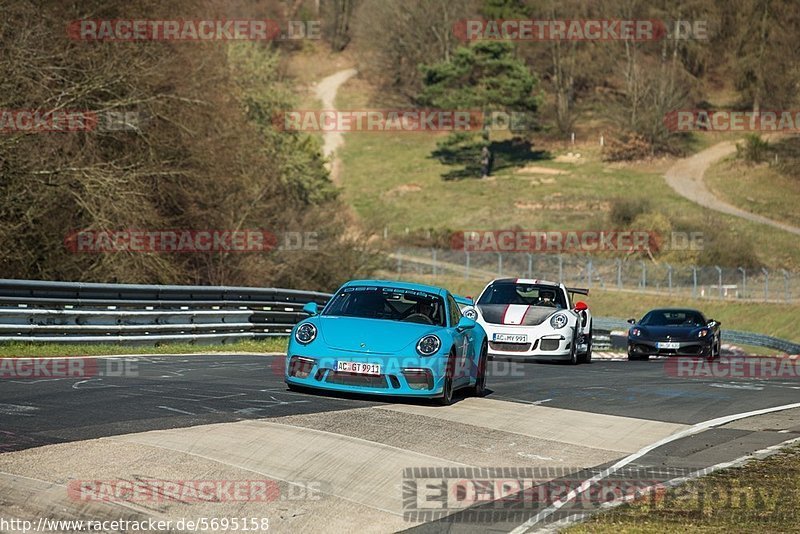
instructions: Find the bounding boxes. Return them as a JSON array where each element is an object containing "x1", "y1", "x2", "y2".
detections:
[{"x1": 560, "y1": 446, "x2": 800, "y2": 534}]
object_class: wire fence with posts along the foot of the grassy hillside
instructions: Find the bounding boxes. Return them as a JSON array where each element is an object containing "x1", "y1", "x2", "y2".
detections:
[{"x1": 392, "y1": 248, "x2": 800, "y2": 303}]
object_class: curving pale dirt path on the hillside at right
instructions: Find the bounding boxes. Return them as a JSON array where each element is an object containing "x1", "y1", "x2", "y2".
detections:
[{"x1": 664, "y1": 141, "x2": 800, "y2": 235}]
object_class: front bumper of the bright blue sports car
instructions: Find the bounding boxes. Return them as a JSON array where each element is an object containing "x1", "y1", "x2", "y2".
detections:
[{"x1": 284, "y1": 353, "x2": 445, "y2": 398}]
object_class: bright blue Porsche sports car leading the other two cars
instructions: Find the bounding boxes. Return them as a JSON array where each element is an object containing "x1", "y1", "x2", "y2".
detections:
[{"x1": 285, "y1": 280, "x2": 487, "y2": 405}]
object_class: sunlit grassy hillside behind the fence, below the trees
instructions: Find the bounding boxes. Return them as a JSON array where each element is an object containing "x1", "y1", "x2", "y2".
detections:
[{"x1": 337, "y1": 79, "x2": 800, "y2": 269}]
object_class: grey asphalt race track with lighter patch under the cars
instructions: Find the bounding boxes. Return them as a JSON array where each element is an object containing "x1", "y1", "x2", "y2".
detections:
[{"x1": 0, "y1": 354, "x2": 800, "y2": 532}]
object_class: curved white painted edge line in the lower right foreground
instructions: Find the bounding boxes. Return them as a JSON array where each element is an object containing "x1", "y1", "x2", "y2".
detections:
[{"x1": 511, "y1": 402, "x2": 800, "y2": 534}]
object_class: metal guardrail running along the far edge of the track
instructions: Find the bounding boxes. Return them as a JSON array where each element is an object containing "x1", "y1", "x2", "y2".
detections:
[{"x1": 0, "y1": 279, "x2": 800, "y2": 354}]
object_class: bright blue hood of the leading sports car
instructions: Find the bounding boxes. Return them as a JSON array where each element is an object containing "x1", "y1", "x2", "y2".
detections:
[{"x1": 317, "y1": 316, "x2": 440, "y2": 353}]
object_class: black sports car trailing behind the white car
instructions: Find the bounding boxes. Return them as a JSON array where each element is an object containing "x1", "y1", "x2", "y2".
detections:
[{"x1": 628, "y1": 308, "x2": 720, "y2": 360}]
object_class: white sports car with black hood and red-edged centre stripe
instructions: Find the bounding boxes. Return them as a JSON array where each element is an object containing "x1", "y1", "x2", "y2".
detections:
[{"x1": 464, "y1": 278, "x2": 592, "y2": 364}]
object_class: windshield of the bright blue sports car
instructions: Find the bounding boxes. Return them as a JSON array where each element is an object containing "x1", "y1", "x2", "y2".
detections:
[{"x1": 322, "y1": 286, "x2": 445, "y2": 326}]
